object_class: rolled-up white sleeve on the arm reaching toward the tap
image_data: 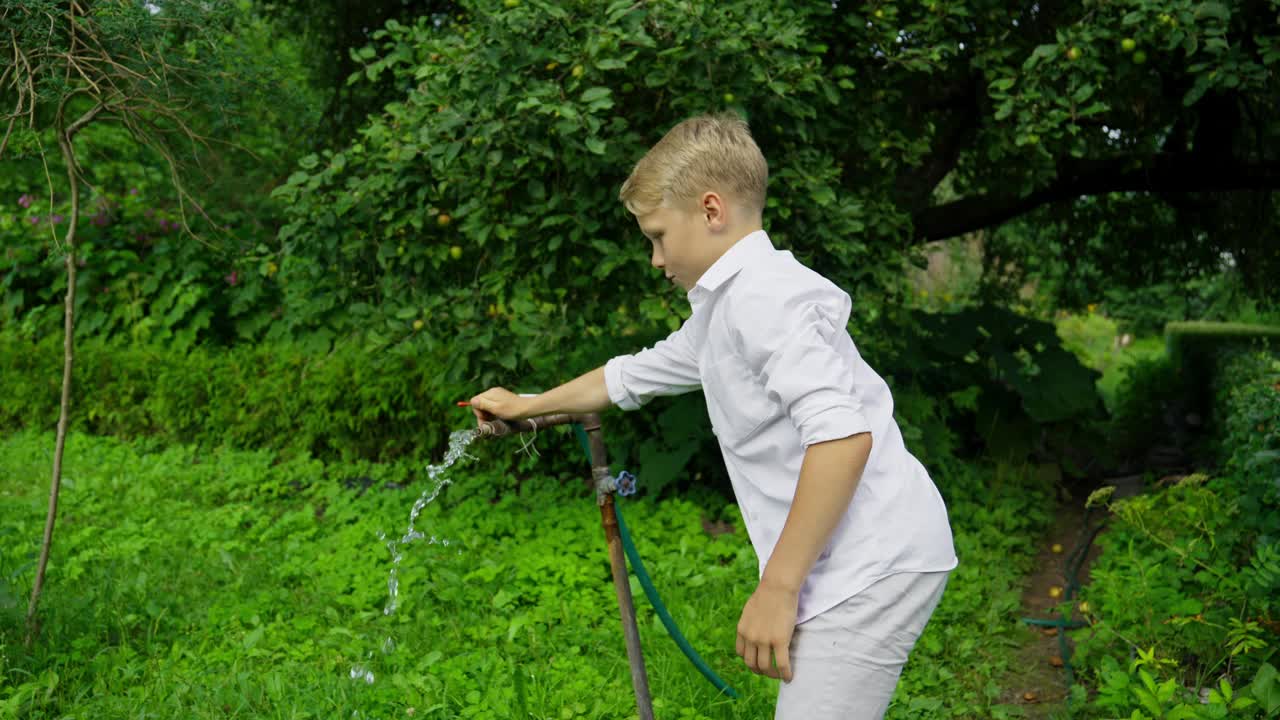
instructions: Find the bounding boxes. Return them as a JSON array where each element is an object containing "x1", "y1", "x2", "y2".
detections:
[{"x1": 604, "y1": 320, "x2": 703, "y2": 410}]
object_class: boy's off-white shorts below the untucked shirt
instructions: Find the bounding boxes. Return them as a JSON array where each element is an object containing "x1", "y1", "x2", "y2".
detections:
[{"x1": 774, "y1": 571, "x2": 950, "y2": 720}]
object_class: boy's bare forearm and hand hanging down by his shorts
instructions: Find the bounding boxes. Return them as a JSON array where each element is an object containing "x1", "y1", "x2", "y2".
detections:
[{"x1": 737, "y1": 433, "x2": 872, "y2": 683}]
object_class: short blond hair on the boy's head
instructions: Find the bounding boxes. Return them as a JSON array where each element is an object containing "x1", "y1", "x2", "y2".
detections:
[{"x1": 618, "y1": 113, "x2": 769, "y2": 215}]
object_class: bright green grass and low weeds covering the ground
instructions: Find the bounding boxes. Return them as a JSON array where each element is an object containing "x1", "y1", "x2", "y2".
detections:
[{"x1": 0, "y1": 432, "x2": 1048, "y2": 720}]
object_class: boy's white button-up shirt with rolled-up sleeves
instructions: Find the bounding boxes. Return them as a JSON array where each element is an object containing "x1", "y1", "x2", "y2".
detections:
[{"x1": 604, "y1": 231, "x2": 956, "y2": 623}]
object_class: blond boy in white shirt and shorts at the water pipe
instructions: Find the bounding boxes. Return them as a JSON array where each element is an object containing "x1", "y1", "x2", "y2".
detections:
[{"x1": 471, "y1": 115, "x2": 956, "y2": 720}]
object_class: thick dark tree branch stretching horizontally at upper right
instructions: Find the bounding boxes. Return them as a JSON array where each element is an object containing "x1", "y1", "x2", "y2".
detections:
[{"x1": 913, "y1": 152, "x2": 1280, "y2": 242}]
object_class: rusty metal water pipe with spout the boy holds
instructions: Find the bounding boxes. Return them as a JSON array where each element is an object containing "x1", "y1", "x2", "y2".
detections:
[{"x1": 477, "y1": 413, "x2": 653, "y2": 720}]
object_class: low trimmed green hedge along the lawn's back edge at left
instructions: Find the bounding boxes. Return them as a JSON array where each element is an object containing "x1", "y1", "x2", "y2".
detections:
[{"x1": 0, "y1": 333, "x2": 462, "y2": 459}]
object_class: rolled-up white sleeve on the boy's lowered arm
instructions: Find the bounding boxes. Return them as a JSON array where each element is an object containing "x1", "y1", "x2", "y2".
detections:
[{"x1": 740, "y1": 294, "x2": 872, "y2": 448}]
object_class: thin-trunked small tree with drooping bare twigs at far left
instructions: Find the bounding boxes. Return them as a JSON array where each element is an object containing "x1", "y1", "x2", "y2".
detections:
[{"x1": 0, "y1": 0, "x2": 252, "y2": 644}]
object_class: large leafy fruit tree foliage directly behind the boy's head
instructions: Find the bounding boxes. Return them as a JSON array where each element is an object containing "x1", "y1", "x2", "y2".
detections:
[{"x1": 271, "y1": 1, "x2": 901, "y2": 368}]
